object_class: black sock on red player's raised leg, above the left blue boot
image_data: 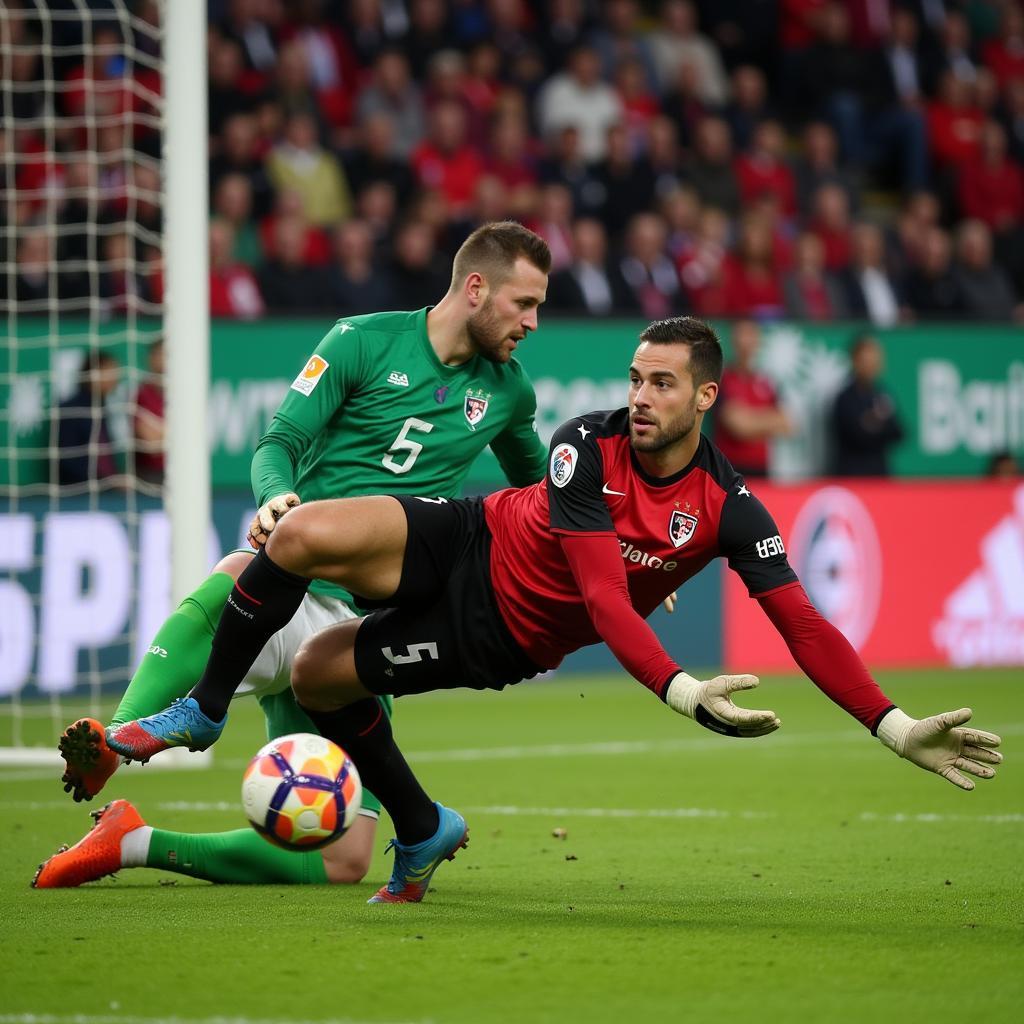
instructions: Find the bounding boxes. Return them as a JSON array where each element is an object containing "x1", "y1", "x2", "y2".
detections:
[{"x1": 189, "y1": 548, "x2": 309, "y2": 722}]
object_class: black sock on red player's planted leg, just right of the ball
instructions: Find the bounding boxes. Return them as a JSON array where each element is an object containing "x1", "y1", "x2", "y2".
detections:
[{"x1": 302, "y1": 698, "x2": 438, "y2": 846}]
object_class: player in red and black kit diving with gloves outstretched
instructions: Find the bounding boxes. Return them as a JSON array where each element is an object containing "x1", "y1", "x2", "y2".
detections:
[{"x1": 123, "y1": 317, "x2": 1001, "y2": 902}]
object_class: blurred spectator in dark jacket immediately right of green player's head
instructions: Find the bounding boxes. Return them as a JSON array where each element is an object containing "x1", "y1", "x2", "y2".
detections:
[{"x1": 547, "y1": 217, "x2": 636, "y2": 316}]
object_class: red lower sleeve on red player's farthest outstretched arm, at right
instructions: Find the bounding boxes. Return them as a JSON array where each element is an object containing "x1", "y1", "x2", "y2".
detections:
[{"x1": 757, "y1": 583, "x2": 894, "y2": 732}]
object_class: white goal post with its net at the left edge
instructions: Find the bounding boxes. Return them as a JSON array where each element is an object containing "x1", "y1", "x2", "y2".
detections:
[{"x1": 0, "y1": 0, "x2": 211, "y2": 767}]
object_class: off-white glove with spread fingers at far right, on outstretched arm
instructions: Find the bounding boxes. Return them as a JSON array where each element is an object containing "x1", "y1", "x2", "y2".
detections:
[{"x1": 877, "y1": 708, "x2": 1002, "y2": 790}]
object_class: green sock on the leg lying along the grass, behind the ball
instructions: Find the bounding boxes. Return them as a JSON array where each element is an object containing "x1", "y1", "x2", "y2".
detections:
[{"x1": 145, "y1": 828, "x2": 327, "y2": 885}]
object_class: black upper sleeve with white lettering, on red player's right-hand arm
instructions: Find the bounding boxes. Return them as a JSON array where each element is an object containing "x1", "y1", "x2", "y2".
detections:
[{"x1": 718, "y1": 478, "x2": 797, "y2": 597}]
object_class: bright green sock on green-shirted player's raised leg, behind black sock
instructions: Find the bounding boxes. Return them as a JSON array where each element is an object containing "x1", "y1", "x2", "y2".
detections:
[{"x1": 111, "y1": 572, "x2": 234, "y2": 729}]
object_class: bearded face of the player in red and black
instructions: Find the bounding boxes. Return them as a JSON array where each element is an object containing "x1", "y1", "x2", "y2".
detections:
[{"x1": 630, "y1": 342, "x2": 717, "y2": 453}]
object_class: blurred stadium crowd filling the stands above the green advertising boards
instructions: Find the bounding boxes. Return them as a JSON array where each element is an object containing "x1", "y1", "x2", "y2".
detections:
[{"x1": 0, "y1": 0, "x2": 1024, "y2": 327}]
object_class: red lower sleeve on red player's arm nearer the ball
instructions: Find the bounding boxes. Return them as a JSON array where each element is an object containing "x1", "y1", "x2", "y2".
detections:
[{"x1": 558, "y1": 534, "x2": 681, "y2": 700}]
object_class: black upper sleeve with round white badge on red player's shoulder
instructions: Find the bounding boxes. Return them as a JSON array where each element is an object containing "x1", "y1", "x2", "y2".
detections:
[{"x1": 546, "y1": 420, "x2": 615, "y2": 534}]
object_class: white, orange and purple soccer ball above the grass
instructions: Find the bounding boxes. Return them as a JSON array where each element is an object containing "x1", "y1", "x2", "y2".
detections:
[{"x1": 242, "y1": 732, "x2": 362, "y2": 850}]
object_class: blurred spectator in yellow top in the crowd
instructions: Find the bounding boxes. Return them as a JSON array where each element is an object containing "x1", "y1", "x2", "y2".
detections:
[{"x1": 266, "y1": 114, "x2": 352, "y2": 225}]
